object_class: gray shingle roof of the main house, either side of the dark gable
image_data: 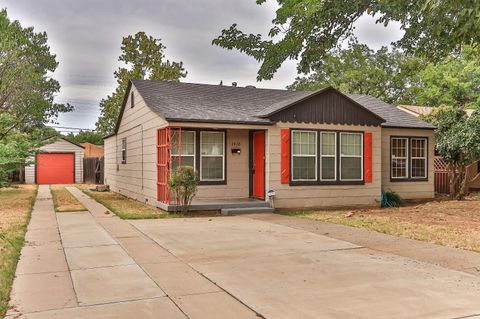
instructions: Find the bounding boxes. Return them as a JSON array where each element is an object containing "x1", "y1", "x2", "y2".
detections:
[{"x1": 132, "y1": 80, "x2": 434, "y2": 128}]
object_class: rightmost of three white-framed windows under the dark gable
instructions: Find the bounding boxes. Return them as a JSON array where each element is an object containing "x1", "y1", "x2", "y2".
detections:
[{"x1": 340, "y1": 133, "x2": 363, "y2": 181}]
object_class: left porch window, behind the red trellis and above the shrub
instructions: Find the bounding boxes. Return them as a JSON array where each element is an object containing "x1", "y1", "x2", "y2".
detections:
[{"x1": 170, "y1": 130, "x2": 195, "y2": 171}]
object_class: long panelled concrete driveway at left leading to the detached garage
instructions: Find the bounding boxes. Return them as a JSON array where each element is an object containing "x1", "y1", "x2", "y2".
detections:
[{"x1": 7, "y1": 186, "x2": 256, "y2": 319}]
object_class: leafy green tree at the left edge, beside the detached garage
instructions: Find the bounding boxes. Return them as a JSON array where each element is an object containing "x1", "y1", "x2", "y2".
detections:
[{"x1": 0, "y1": 10, "x2": 73, "y2": 186}]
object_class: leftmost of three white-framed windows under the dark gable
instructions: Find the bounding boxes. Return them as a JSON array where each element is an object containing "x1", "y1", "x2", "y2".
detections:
[{"x1": 292, "y1": 131, "x2": 317, "y2": 181}]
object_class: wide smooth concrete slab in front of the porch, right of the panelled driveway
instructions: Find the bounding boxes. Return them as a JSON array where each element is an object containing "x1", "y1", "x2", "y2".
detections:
[{"x1": 131, "y1": 217, "x2": 480, "y2": 318}]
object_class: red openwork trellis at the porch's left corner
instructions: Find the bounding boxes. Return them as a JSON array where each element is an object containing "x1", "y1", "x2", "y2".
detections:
[{"x1": 157, "y1": 126, "x2": 182, "y2": 204}]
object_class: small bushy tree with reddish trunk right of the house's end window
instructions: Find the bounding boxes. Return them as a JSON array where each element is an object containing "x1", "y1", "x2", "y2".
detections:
[{"x1": 425, "y1": 106, "x2": 480, "y2": 199}]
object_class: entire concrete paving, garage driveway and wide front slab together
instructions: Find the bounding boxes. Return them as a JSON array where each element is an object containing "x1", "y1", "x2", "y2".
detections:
[{"x1": 7, "y1": 186, "x2": 480, "y2": 319}]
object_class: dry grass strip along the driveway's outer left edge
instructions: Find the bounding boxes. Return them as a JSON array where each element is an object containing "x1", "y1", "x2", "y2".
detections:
[{"x1": 0, "y1": 185, "x2": 37, "y2": 317}]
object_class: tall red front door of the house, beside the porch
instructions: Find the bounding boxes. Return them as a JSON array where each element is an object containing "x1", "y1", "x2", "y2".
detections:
[{"x1": 253, "y1": 131, "x2": 265, "y2": 198}]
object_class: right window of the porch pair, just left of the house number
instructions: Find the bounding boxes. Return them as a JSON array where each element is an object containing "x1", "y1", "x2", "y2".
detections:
[{"x1": 200, "y1": 131, "x2": 225, "y2": 181}]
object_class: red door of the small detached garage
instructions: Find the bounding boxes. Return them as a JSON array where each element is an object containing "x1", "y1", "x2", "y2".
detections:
[{"x1": 36, "y1": 153, "x2": 75, "y2": 184}]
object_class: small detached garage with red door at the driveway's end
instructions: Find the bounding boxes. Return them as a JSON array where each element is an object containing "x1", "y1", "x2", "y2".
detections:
[{"x1": 25, "y1": 138, "x2": 84, "y2": 184}]
